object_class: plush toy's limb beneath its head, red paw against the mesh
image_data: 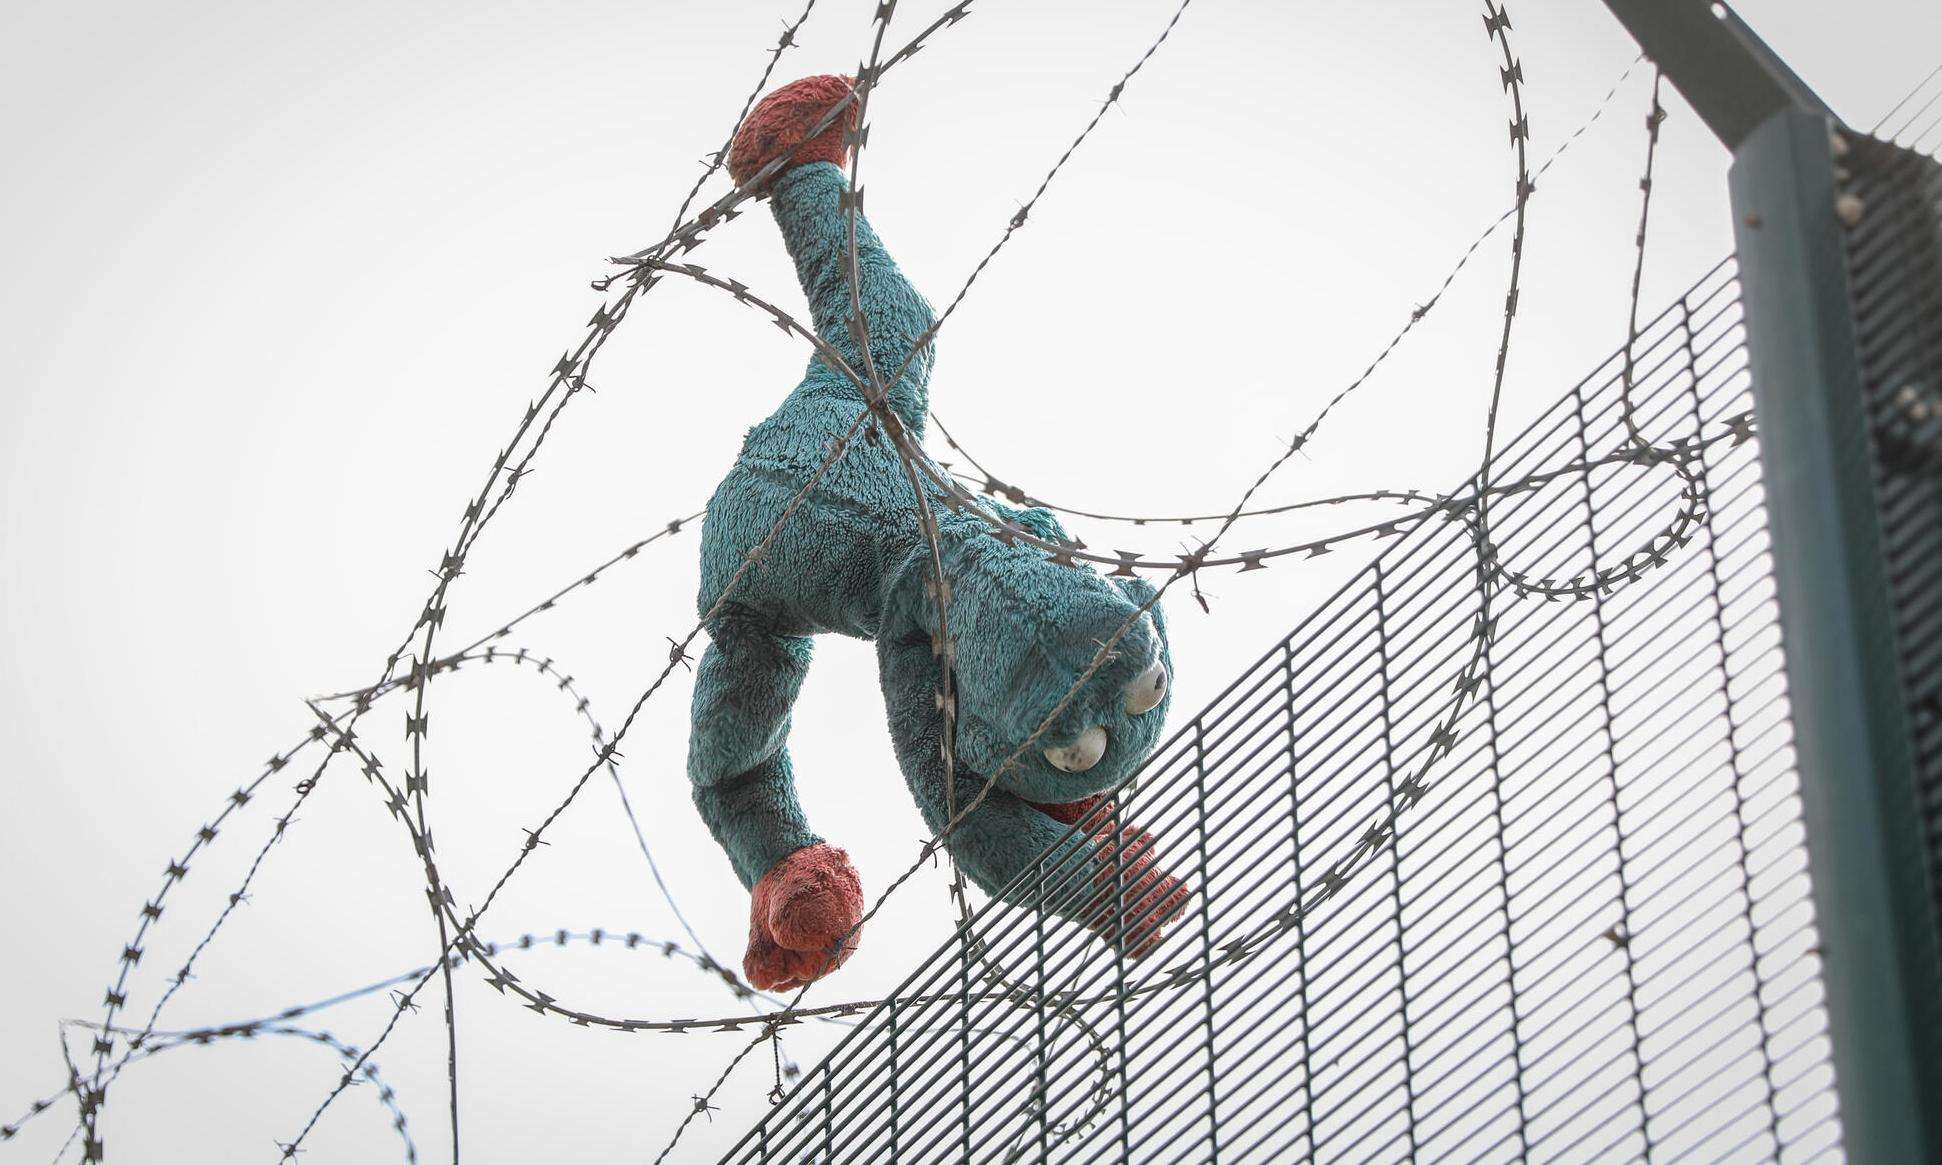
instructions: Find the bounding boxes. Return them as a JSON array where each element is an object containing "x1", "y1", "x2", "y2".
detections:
[{"x1": 878, "y1": 639, "x2": 1189, "y2": 957}]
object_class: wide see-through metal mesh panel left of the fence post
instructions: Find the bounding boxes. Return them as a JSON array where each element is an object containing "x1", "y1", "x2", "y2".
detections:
[{"x1": 730, "y1": 264, "x2": 1839, "y2": 1161}]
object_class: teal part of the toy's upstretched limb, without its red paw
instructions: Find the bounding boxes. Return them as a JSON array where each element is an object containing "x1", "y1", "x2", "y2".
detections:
[{"x1": 773, "y1": 161, "x2": 934, "y2": 437}]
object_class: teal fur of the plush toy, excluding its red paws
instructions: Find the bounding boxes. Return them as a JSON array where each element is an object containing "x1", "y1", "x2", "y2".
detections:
[{"x1": 687, "y1": 161, "x2": 1173, "y2": 913}]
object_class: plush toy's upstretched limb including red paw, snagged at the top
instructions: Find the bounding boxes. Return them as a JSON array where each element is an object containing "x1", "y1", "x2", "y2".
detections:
[{"x1": 728, "y1": 76, "x2": 932, "y2": 435}]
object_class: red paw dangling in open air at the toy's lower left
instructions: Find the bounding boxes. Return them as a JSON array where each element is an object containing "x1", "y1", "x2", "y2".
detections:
[{"x1": 742, "y1": 843, "x2": 862, "y2": 990}]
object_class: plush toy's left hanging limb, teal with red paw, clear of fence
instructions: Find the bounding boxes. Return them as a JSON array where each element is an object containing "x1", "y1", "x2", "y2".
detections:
[{"x1": 687, "y1": 616, "x2": 862, "y2": 990}]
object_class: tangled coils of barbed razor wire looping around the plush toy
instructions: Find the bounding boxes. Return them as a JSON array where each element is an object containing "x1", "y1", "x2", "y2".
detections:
[{"x1": 0, "y1": 0, "x2": 1752, "y2": 1161}]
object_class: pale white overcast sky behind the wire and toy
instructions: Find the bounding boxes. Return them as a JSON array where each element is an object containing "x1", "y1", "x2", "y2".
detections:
[{"x1": 0, "y1": 0, "x2": 1942, "y2": 1161}]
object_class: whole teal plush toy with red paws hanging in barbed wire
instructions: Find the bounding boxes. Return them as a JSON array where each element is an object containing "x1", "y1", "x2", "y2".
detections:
[{"x1": 687, "y1": 76, "x2": 1187, "y2": 990}]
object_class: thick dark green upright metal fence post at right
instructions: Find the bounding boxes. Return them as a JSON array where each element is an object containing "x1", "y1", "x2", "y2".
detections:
[{"x1": 1730, "y1": 109, "x2": 1942, "y2": 1165}]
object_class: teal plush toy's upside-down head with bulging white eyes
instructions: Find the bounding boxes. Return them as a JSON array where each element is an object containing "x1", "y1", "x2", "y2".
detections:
[{"x1": 928, "y1": 511, "x2": 1173, "y2": 804}]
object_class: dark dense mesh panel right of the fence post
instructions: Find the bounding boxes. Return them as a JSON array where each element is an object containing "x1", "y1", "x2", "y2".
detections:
[{"x1": 1845, "y1": 138, "x2": 1942, "y2": 947}]
